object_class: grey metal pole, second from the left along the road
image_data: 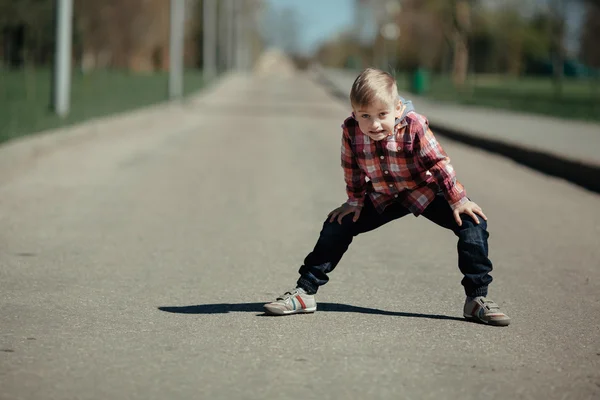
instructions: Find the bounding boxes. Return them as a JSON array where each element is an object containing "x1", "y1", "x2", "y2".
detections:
[{"x1": 169, "y1": 0, "x2": 185, "y2": 99}]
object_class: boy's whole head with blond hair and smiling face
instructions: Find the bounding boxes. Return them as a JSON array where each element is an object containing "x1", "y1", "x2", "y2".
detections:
[{"x1": 350, "y1": 68, "x2": 401, "y2": 140}]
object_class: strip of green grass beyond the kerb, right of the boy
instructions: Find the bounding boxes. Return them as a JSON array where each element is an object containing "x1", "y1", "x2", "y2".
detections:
[{"x1": 408, "y1": 76, "x2": 600, "y2": 121}]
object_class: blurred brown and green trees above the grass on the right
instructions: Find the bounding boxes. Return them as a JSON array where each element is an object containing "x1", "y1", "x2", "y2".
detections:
[{"x1": 316, "y1": 0, "x2": 600, "y2": 85}]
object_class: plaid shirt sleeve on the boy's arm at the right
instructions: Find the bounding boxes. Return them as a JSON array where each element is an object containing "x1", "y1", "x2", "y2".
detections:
[{"x1": 415, "y1": 120, "x2": 469, "y2": 210}]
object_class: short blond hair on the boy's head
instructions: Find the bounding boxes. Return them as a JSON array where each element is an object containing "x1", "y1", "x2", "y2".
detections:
[{"x1": 350, "y1": 68, "x2": 398, "y2": 108}]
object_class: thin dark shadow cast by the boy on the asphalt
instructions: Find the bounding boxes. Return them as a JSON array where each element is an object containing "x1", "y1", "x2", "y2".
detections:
[{"x1": 158, "y1": 303, "x2": 465, "y2": 321}]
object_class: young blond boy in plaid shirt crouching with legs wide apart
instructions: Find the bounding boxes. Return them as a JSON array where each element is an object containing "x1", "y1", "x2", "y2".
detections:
[{"x1": 264, "y1": 68, "x2": 510, "y2": 326}]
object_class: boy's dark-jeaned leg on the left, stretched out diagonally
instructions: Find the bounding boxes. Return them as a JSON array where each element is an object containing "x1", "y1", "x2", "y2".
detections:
[{"x1": 297, "y1": 196, "x2": 409, "y2": 294}]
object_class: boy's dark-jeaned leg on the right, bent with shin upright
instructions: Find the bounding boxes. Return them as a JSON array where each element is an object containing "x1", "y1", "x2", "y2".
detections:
[{"x1": 423, "y1": 194, "x2": 492, "y2": 297}]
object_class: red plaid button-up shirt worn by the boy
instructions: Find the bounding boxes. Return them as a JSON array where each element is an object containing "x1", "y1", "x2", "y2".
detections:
[{"x1": 342, "y1": 111, "x2": 468, "y2": 215}]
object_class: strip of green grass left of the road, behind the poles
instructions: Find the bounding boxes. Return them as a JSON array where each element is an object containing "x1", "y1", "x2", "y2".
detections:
[{"x1": 0, "y1": 69, "x2": 204, "y2": 142}]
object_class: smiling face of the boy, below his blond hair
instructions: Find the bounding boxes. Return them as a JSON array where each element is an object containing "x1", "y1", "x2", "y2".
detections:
[{"x1": 354, "y1": 101, "x2": 400, "y2": 140}]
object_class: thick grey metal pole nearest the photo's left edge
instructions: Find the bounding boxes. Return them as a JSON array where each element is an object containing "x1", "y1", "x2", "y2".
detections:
[{"x1": 54, "y1": 0, "x2": 73, "y2": 118}]
